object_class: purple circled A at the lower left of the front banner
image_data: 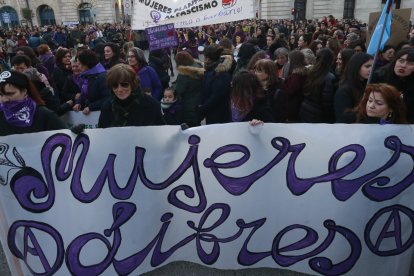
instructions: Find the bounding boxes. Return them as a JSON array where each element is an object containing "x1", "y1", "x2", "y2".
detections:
[{"x1": 7, "y1": 220, "x2": 64, "y2": 275}]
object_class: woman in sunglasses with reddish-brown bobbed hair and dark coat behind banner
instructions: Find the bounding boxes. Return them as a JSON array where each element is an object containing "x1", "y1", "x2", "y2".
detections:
[{"x1": 98, "y1": 64, "x2": 165, "y2": 128}]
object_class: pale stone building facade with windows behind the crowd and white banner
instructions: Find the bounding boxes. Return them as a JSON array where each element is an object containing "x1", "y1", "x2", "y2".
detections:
[{"x1": 0, "y1": 0, "x2": 414, "y2": 26}]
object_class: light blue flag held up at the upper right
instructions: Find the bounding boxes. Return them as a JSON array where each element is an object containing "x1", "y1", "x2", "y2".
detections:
[{"x1": 367, "y1": 0, "x2": 394, "y2": 55}]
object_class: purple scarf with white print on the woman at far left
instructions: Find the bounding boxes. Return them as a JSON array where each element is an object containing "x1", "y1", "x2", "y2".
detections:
[{"x1": 0, "y1": 97, "x2": 36, "y2": 127}]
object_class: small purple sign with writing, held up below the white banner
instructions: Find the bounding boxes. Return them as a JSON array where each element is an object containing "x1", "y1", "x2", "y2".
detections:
[{"x1": 145, "y1": 24, "x2": 178, "y2": 51}]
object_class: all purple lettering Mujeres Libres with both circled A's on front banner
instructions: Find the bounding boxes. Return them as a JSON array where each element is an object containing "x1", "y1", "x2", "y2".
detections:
[{"x1": 0, "y1": 130, "x2": 414, "y2": 275}]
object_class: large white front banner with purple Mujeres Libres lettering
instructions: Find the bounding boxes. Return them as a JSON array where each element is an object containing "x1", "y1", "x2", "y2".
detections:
[{"x1": 0, "y1": 123, "x2": 414, "y2": 276}]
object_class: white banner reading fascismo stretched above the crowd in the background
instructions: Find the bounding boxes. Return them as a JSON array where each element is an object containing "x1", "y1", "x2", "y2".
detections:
[{"x1": 132, "y1": 0, "x2": 254, "y2": 30}]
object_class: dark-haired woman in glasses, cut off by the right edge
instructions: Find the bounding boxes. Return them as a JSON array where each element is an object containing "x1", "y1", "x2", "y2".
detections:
[{"x1": 372, "y1": 48, "x2": 414, "y2": 123}]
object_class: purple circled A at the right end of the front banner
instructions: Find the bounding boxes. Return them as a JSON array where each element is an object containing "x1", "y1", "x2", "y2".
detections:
[{"x1": 364, "y1": 205, "x2": 414, "y2": 257}]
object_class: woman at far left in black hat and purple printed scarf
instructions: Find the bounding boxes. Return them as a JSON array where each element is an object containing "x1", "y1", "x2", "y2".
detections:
[{"x1": 0, "y1": 71, "x2": 67, "y2": 136}]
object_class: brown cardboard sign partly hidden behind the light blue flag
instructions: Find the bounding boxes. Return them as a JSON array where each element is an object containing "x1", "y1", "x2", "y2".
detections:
[{"x1": 366, "y1": 8, "x2": 411, "y2": 47}]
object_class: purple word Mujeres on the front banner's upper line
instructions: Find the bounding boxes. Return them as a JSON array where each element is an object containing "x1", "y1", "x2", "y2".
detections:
[{"x1": 5, "y1": 134, "x2": 414, "y2": 213}]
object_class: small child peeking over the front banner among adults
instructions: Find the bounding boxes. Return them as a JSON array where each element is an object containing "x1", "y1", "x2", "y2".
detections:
[{"x1": 161, "y1": 87, "x2": 183, "y2": 125}]
